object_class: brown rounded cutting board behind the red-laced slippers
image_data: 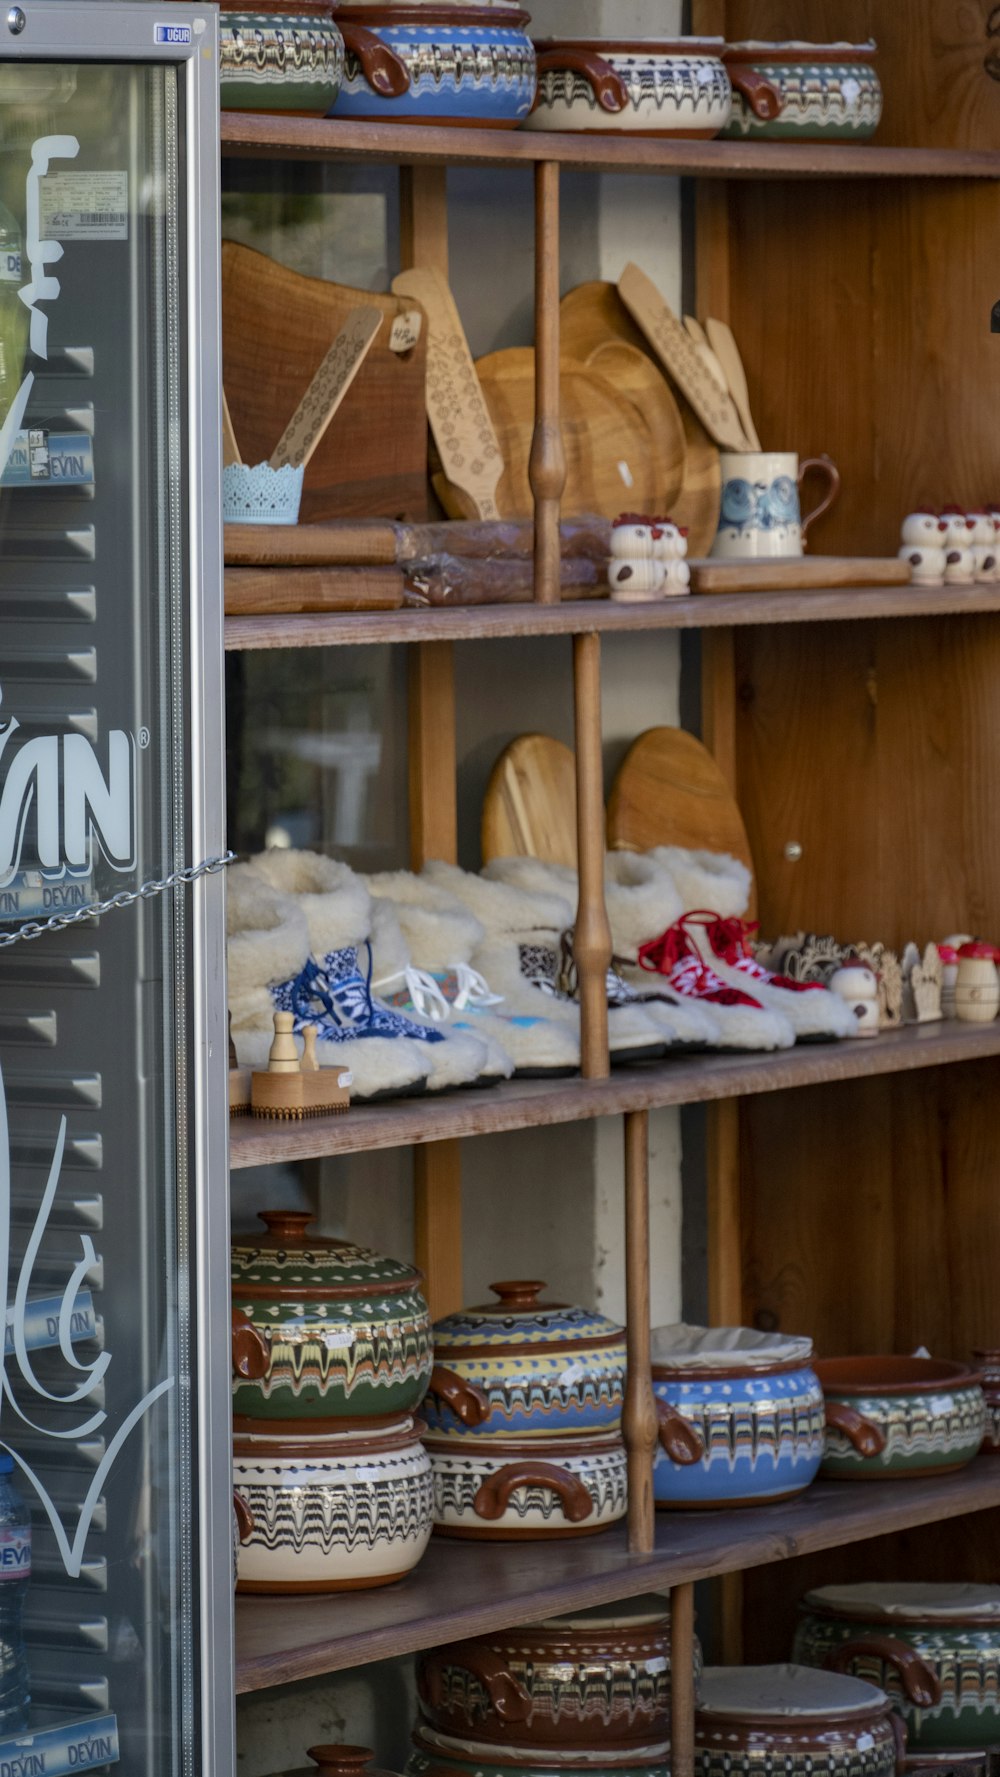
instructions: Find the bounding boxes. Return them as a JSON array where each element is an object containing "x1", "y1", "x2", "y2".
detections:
[{"x1": 607, "y1": 729, "x2": 757, "y2": 919}]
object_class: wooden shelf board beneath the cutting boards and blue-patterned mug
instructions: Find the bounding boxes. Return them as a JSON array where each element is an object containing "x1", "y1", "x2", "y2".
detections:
[{"x1": 226, "y1": 586, "x2": 1000, "y2": 650}]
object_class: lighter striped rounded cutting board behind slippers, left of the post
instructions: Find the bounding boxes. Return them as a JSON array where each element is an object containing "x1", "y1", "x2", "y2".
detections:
[{"x1": 481, "y1": 734, "x2": 577, "y2": 871}]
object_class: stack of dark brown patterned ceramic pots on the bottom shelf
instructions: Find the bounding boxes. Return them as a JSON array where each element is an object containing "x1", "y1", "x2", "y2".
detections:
[{"x1": 407, "y1": 1598, "x2": 702, "y2": 1777}]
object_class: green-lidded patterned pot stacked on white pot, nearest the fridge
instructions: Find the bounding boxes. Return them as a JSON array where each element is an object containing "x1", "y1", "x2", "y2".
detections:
[{"x1": 233, "y1": 1210, "x2": 432, "y2": 1592}]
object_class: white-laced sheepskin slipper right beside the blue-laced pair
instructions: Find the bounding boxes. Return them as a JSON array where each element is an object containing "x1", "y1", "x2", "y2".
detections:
[{"x1": 371, "y1": 896, "x2": 513, "y2": 1093}]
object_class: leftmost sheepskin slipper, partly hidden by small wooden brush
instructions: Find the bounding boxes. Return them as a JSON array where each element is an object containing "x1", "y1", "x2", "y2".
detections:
[{"x1": 226, "y1": 858, "x2": 430, "y2": 1098}]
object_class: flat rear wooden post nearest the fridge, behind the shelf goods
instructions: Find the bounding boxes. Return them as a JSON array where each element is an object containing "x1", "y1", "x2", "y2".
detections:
[{"x1": 400, "y1": 167, "x2": 464, "y2": 1319}]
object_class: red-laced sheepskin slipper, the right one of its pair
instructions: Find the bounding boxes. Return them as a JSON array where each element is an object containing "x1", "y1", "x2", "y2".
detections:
[{"x1": 650, "y1": 846, "x2": 856, "y2": 1043}]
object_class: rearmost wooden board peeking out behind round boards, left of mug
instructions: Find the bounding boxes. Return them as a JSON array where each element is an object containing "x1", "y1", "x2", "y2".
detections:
[{"x1": 560, "y1": 283, "x2": 723, "y2": 556}]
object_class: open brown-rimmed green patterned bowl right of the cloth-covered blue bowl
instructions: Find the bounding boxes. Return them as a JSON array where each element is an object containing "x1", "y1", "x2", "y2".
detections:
[{"x1": 815, "y1": 1358, "x2": 986, "y2": 1480}]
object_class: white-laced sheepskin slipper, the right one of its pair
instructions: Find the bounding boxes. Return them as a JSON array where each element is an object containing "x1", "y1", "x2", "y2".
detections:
[{"x1": 364, "y1": 871, "x2": 579, "y2": 1079}]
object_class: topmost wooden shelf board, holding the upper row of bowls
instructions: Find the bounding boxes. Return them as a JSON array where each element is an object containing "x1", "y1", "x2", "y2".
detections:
[{"x1": 222, "y1": 112, "x2": 1000, "y2": 179}]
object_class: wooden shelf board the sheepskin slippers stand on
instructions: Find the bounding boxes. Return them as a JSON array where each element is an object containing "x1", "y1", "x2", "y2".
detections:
[{"x1": 229, "y1": 1020, "x2": 1000, "y2": 1169}]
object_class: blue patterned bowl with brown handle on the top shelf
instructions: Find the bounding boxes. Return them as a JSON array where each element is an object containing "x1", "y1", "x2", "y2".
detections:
[{"x1": 334, "y1": 4, "x2": 535, "y2": 130}]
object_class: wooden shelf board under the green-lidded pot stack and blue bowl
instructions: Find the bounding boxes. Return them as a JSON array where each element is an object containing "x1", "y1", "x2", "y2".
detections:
[{"x1": 236, "y1": 1457, "x2": 1000, "y2": 1693}]
